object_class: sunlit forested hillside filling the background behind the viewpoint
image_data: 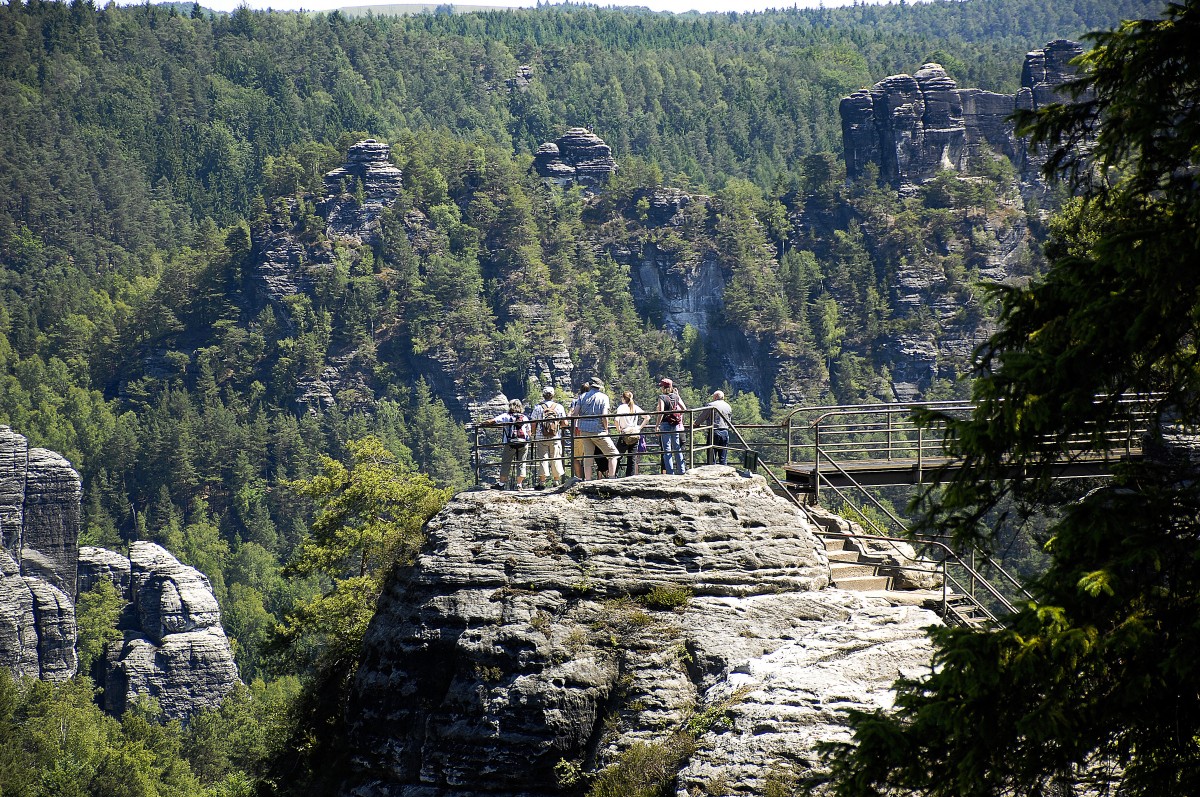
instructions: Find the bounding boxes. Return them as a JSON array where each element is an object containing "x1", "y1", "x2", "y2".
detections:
[{"x1": 0, "y1": 0, "x2": 1159, "y2": 793}]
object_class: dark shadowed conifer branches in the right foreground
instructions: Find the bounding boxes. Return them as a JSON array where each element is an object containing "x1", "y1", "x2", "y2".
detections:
[{"x1": 829, "y1": 1, "x2": 1200, "y2": 797}]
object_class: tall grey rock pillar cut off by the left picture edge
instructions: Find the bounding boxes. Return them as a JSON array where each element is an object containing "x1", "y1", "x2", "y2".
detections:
[{"x1": 0, "y1": 426, "x2": 80, "y2": 681}]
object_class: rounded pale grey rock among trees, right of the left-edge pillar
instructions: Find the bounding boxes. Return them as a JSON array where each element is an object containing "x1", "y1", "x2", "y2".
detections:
[{"x1": 80, "y1": 543, "x2": 238, "y2": 720}]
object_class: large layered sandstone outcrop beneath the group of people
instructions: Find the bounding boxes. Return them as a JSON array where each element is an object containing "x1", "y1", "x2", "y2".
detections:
[{"x1": 346, "y1": 466, "x2": 936, "y2": 797}]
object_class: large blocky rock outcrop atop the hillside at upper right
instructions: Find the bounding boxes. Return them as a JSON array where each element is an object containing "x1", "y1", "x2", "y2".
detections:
[{"x1": 840, "y1": 40, "x2": 1082, "y2": 188}]
